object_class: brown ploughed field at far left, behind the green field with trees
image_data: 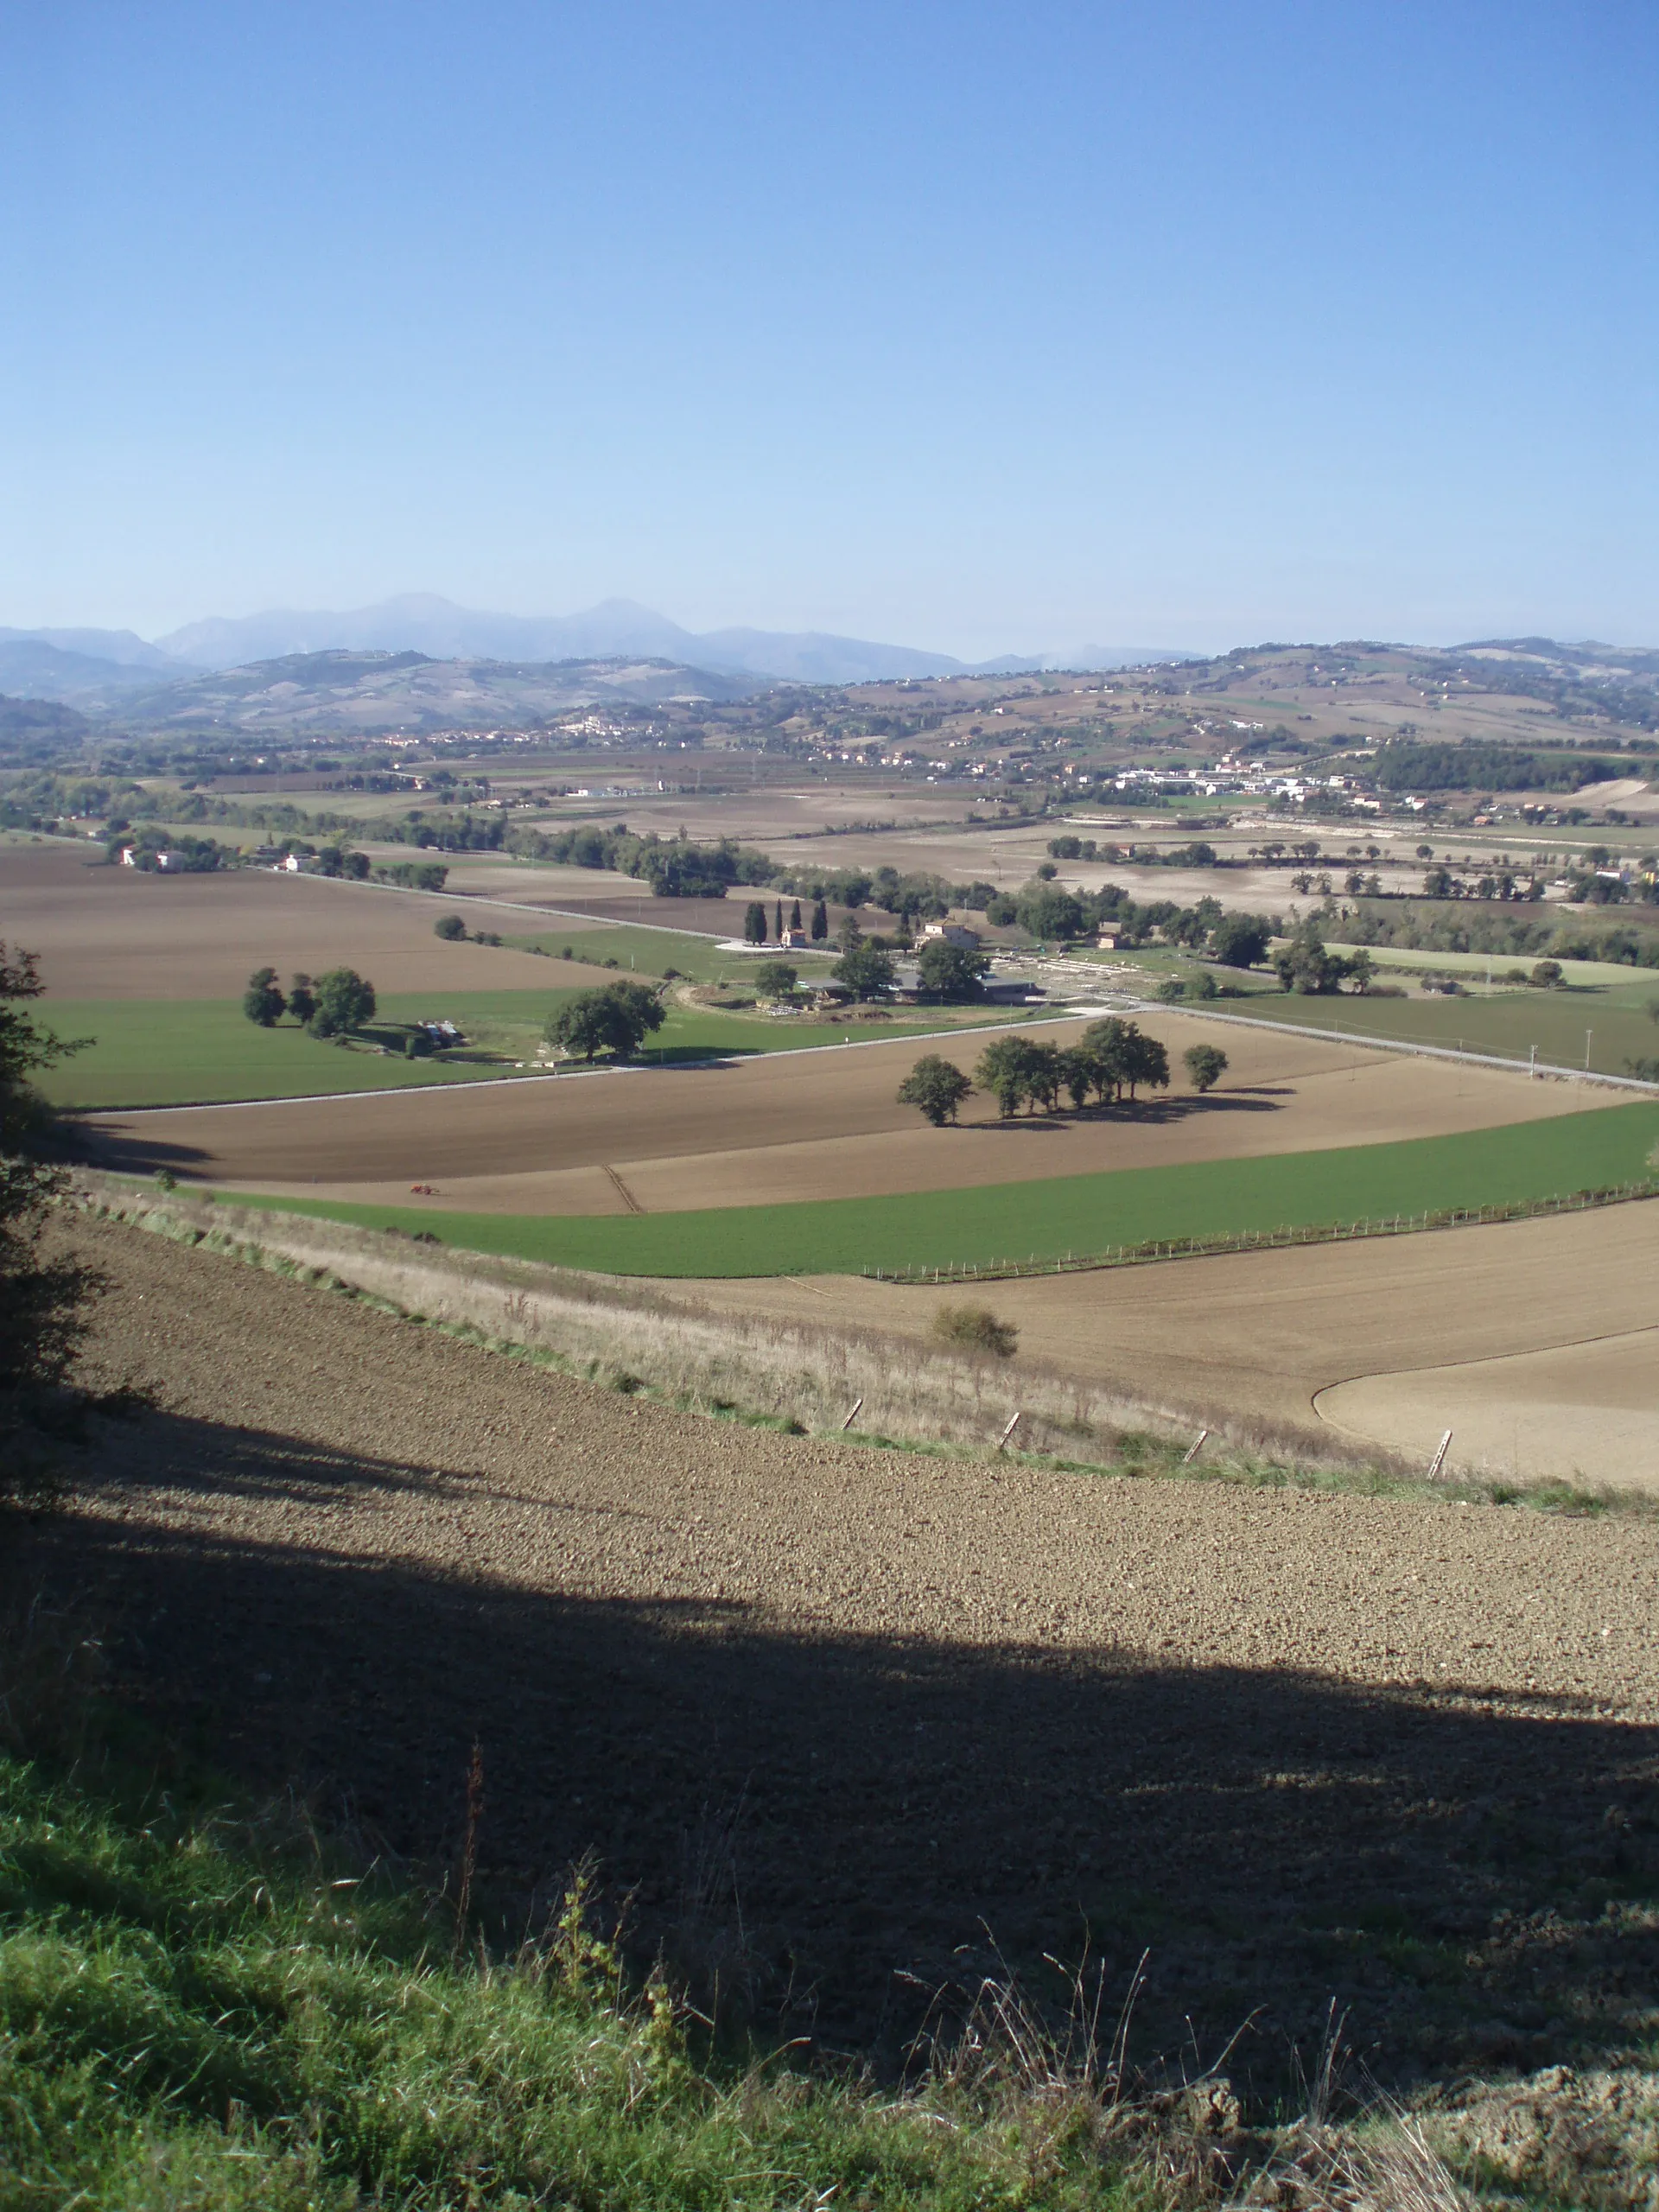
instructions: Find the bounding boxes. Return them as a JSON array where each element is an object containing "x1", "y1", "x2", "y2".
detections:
[{"x1": 0, "y1": 841, "x2": 615, "y2": 998}]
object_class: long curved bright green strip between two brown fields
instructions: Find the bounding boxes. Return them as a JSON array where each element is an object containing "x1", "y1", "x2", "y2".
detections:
[{"x1": 224, "y1": 1099, "x2": 1659, "y2": 1276}]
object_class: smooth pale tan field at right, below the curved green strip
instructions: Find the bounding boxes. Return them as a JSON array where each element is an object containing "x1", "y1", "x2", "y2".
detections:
[{"x1": 672, "y1": 1204, "x2": 1659, "y2": 1491}]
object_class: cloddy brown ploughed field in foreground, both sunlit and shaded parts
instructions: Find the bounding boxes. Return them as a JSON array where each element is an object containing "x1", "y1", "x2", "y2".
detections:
[{"x1": 22, "y1": 1224, "x2": 1659, "y2": 2082}]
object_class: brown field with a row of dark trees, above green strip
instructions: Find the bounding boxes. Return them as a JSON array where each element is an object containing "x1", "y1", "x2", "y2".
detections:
[{"x1": 84, "y1": 1013, "x2": 1606, "y2": 1214}]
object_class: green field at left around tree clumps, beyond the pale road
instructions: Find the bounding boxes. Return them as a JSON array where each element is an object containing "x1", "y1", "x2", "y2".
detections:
[{"x1": 40, "y1": 987, "x2": 1065, "y2": 1110}]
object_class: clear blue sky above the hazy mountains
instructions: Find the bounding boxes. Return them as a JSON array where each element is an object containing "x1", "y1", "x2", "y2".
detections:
[{"x1": 0, "y1": 0, "x2": 1659, "y2": 655}]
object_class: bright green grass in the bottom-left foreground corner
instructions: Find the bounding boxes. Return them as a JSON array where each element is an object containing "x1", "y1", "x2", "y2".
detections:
[{"x1": 0, "y1": 1757, "x2": 1146, "y2": 2212}]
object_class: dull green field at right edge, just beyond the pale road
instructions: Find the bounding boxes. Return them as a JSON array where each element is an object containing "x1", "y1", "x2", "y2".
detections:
[{"x1": 1217, "y1": 982, "x2": 1659, "y2": 1075}]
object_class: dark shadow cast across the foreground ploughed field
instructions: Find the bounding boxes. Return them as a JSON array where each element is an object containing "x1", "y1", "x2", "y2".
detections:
[{"x1": 11, "y1": 1415, "x2": 1659, "y2": 2094}]
